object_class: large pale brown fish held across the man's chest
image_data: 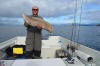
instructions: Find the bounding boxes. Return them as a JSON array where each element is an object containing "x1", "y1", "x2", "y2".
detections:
[{"x1": 22, "y1": 13, "x2": 52, "y2": 32}]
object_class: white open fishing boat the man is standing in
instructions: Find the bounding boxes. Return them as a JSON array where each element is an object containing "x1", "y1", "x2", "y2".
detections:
[{"x1": 0, "y1": 36, "x2": 100, "y2": 66}]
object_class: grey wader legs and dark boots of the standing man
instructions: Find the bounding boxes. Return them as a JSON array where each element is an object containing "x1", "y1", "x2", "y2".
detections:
[{"x1": 25, "y1": 30, "x2": 41, "y2": 57}]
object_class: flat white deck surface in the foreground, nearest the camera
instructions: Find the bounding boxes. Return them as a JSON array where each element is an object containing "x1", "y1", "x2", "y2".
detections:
[{"x1": 2, "y1": 58, "x2": 85, "y2": 66}]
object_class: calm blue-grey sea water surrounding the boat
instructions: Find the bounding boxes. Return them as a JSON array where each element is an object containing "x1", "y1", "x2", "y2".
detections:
[{"x1": 0, "y1": 25, "x2": 100, "y2": 51}]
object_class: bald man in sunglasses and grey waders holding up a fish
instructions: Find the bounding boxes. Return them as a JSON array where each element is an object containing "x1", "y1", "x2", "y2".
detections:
[{"x1": 24, "y1": 6, "x2": 42, "y2": 58}]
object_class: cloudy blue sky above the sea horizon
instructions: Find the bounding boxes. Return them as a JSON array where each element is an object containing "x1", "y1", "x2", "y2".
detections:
[{"x1": 0, "y1": 0, "x2": 100, "y2": 24}]
